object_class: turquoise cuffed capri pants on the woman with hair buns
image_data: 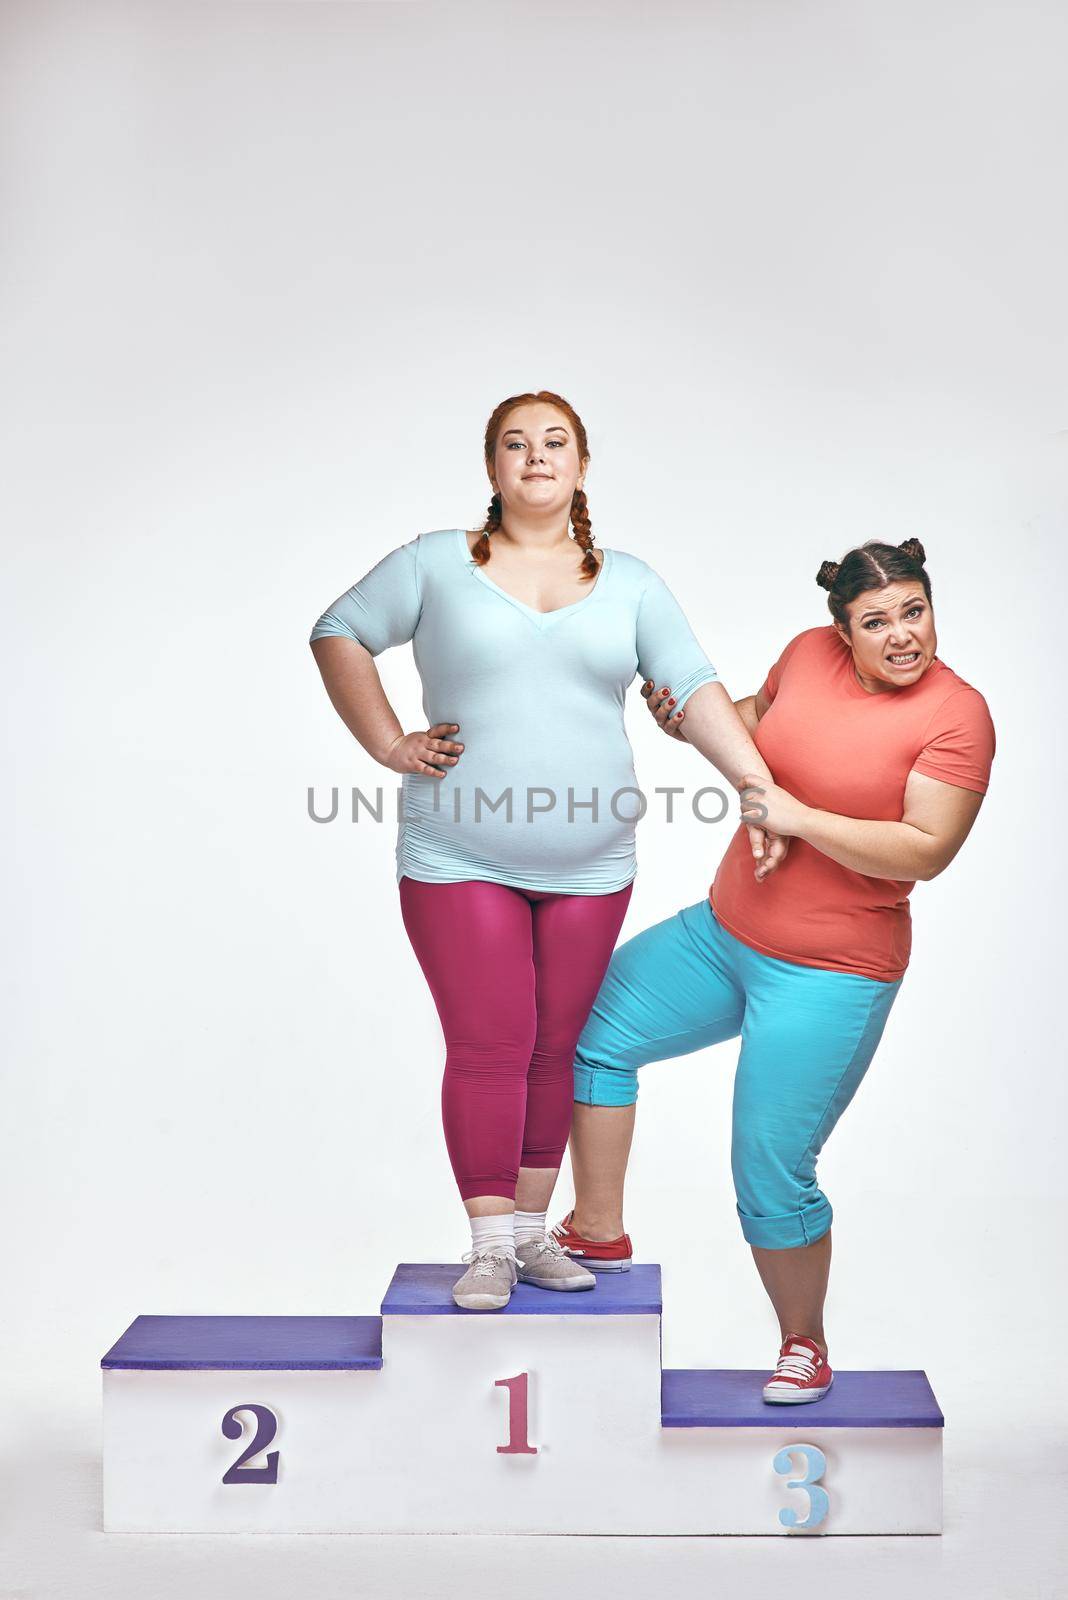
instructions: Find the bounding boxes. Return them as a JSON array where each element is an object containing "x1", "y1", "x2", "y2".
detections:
[{"x1": 574, "y1": 899, "x2": 903, "y2": 1250}]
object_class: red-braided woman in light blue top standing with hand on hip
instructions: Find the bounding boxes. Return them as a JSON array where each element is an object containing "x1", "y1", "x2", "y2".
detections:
[{"x1": 312, "y1": 390, "x2": 785, "y2": 1310}]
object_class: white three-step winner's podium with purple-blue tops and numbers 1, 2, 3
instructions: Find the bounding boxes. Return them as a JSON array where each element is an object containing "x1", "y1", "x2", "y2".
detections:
[{"x1": 101, "y1": 1266, "x2": 943, "y2": 1536}]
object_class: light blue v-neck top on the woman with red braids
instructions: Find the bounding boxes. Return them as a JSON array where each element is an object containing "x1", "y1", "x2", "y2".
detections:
[{"x1": 312, "y1": 528, "x2": 716, "y2": 894}]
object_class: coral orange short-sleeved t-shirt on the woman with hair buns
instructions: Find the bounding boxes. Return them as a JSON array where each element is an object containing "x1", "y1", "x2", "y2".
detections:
[{"x1": 710, "y1": 626, "x2": 994, "y2": 982}]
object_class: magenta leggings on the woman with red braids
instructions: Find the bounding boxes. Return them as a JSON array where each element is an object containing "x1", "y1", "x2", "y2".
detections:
[{"x1": 400, "y1": 877, "x2": 633, "y2": 1200}]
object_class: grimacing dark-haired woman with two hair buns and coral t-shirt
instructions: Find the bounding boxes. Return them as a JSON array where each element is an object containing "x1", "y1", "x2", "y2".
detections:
[{"x1": 553, "y1": 539, "x2": 994, "y2": 1403}]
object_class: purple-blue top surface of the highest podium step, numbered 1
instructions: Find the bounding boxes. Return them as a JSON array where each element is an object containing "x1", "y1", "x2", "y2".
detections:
[{"x1": 382, "y1": 1262, "x2": 662, "y2": 1317}]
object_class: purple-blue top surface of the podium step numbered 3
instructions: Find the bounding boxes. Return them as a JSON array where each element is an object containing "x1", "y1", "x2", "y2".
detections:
[{"x1": 660, "y1": 1368, "x2": 945, "y2": 1437}]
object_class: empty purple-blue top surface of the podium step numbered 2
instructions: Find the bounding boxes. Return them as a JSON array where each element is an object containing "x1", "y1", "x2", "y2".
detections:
[{"x1": 101, "y1": 1317, "x2": 382, "y2": 1371}]
